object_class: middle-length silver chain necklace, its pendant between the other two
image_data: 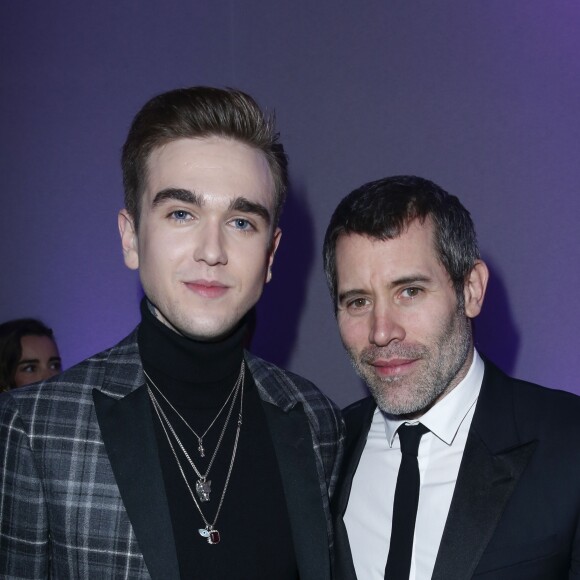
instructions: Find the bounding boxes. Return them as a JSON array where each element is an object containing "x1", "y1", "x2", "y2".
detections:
[{"x1": 143, "y1": 368, "x2": 245, "y2": 502}]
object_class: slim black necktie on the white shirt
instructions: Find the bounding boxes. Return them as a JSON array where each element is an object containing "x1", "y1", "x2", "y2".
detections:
[{"x1": 385, "y1": 423, "x2": 429, "y2": 580}]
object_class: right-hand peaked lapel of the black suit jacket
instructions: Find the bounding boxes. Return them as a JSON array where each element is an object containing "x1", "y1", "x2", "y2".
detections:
[{"x1": 432, "y1": 362, "x2": 536, "y2": 580}]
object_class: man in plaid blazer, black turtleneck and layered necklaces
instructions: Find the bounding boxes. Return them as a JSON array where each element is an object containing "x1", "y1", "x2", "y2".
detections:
[{"x1": 0, "y1": 87, "x2": 342, "y2": 580}]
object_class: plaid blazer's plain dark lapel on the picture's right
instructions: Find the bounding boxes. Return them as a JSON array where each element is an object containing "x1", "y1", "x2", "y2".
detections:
[{"x1": 263, "y1": 402, "x2": 330, "y2": 580}]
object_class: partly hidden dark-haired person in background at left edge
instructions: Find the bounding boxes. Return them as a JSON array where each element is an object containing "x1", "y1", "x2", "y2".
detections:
[{"x1": 0, "y1": 318, "x2": 62, "y2": 391}]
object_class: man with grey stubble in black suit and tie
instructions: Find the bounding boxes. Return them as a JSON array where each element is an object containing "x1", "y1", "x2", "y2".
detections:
[{"x1": 324, "y1": 176, "x2": 580, "y2": 580}]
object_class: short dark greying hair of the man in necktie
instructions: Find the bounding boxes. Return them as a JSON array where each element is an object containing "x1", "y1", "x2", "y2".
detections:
[{"x1": 323, "y1": 175, "x2": 479, "y2": 310}]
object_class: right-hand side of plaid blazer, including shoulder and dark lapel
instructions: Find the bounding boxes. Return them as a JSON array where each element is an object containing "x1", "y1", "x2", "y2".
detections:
[{"x1": 246, "y1": 353, "x2": 344, "y2": 580}]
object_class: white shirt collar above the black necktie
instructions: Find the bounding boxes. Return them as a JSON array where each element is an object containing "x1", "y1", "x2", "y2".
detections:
[{"x1": 375, "y1": 350, "x2": 484, "y2": 447}]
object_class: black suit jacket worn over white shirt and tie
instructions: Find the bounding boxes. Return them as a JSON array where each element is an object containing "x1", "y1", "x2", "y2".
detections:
[{"x1": 333, "y1": 361, "x2": 580, "y2": 580}]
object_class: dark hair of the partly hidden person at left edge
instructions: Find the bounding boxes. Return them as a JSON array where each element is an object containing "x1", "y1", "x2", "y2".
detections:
[{"x1": 0, "y1": 318, "x2": 54, "y2": 391}]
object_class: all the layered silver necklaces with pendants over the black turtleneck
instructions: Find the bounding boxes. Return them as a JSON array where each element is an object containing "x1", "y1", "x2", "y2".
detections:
[{"x1": 143, "y1": 361, "x2": 245, "y2": 544}]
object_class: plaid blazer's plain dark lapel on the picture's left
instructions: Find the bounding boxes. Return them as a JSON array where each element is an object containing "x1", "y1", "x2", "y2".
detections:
[{"x1": 93, "y1": 385, "x2": 180, "y2": 580}]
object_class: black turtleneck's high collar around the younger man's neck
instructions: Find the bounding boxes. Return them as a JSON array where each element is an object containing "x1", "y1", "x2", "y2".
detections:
[{"x1": 138, "y1": 298, "x2": 248, "y2": 383}]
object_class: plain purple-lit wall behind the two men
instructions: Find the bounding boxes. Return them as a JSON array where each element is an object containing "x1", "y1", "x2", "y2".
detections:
[{"x1": 0, "y1": 0, "x2": 580, "y2": 405}]
